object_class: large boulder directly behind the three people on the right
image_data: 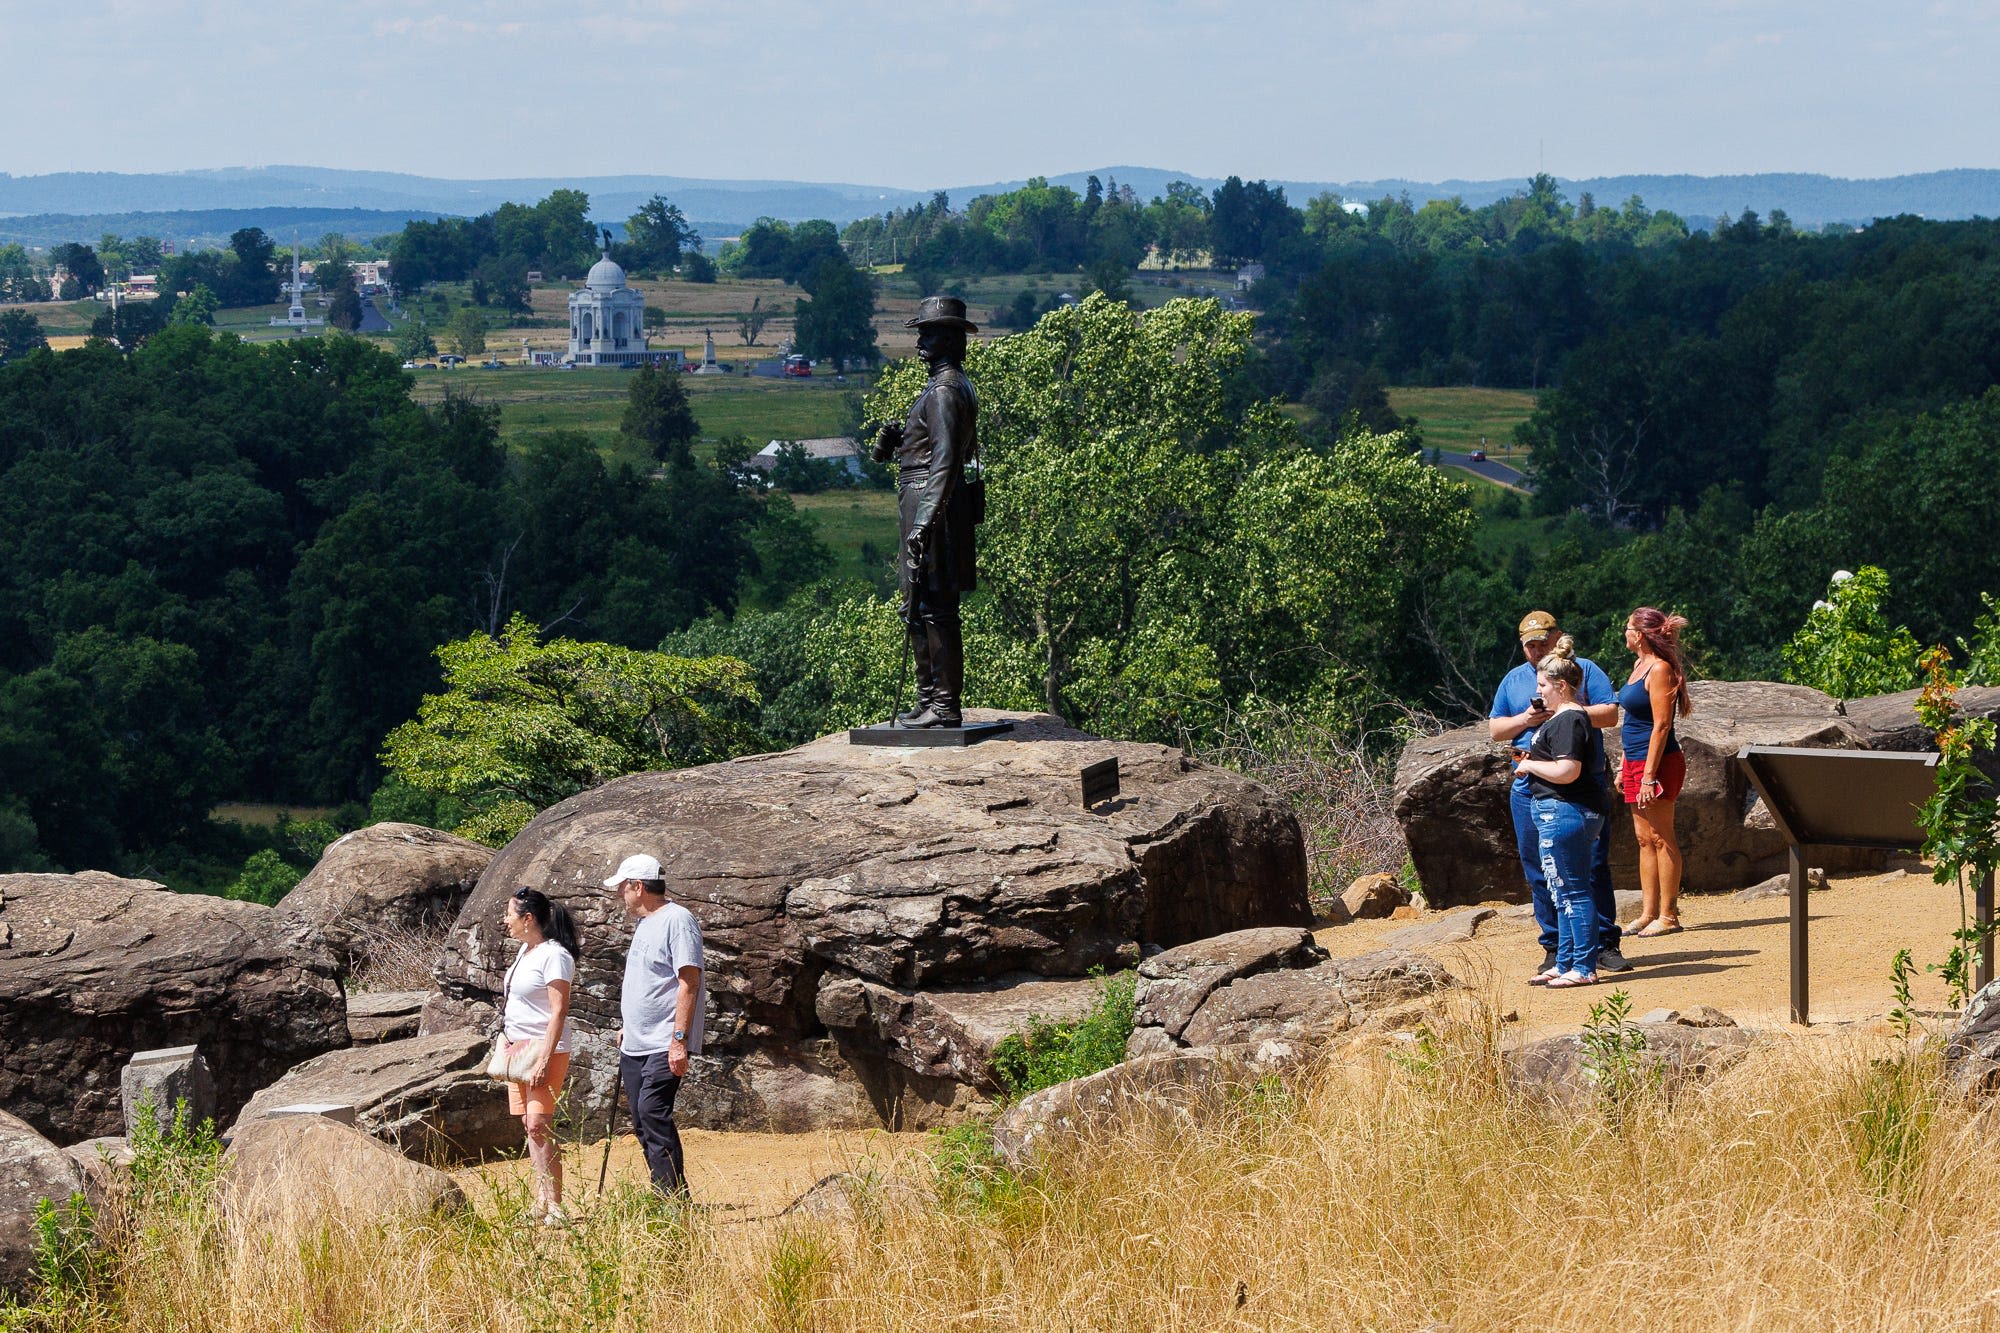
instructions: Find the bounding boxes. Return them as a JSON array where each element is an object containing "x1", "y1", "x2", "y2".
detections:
[{"x1": 1394, "y1": 681, "x2": 1886, "y2": 907}]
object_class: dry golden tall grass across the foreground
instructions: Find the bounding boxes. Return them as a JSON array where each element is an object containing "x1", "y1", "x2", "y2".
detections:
[{"x1": 27, "y1": 1003, "x2": 2000, "y2": 1333}]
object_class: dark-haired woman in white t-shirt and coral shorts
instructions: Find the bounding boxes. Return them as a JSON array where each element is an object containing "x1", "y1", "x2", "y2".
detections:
[{"x1": 502, "y1": 889, "x2": 578, "y2": 1225}]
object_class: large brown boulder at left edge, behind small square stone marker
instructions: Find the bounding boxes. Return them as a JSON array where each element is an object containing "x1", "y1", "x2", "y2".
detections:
[{"x1": 0, "y1": 871, "x2": 348, "y2": 1143}]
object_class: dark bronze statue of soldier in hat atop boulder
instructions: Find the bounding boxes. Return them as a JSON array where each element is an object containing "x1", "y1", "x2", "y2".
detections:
[{"x1": 874, "y1": 296, "x2": 986, "y2": 727}]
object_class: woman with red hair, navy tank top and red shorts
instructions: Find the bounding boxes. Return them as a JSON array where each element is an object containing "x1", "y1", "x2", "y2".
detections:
[{"x1": 1618, "y1": 606, "x2": 1694, "y2": 939}]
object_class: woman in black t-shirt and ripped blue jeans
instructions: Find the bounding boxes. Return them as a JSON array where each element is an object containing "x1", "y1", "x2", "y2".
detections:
[{"x1": 1514, "y1": 634, "x2": 1604, "y2": 987}]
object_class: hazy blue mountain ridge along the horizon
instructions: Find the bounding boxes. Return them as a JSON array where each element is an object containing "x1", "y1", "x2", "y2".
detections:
[{"x1": 0, "y1": 166, "x2": 2000, "y2": 244}]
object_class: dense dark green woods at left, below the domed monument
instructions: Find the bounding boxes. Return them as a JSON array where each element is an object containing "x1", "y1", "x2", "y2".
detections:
[{"x1": 0, "y1": 326, "x2": 826, "y2": 869}]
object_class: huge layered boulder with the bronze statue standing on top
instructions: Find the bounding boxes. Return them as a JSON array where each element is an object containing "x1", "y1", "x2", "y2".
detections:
[{"x1": 426, "y1": 713, "x2": 1310, "y2": 1129}]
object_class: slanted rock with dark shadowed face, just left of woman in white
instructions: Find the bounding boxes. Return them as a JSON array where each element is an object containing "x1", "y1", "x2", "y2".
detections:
[{"x1": 230, "y1": 1029, "x2": 522, "y2": 1163}]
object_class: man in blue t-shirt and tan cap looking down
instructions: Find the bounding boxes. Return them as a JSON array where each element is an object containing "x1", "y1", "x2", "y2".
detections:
[{"x1": 1486, "y1": 610, "x2": 1632, "y2": 973}]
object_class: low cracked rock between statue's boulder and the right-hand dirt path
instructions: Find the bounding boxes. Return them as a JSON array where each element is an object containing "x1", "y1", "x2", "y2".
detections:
[{"x1": 1126, "y1": 931, "x2": 1458, "y2": 1057}]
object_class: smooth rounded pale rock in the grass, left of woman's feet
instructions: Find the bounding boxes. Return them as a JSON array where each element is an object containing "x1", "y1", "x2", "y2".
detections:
[{"x1": 220, "y1": 1115, "x2": 468, "y2": 1229}]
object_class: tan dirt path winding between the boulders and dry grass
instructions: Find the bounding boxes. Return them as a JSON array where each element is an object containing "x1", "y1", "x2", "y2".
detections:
[{"x1": 460, "y1": 860, "x2": 1958, "y2": 1221}]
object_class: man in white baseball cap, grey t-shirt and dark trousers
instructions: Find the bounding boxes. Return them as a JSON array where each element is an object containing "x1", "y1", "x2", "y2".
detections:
[{"x1": 604, "y1": 853, "x2": 708, "y2": 1199}]
